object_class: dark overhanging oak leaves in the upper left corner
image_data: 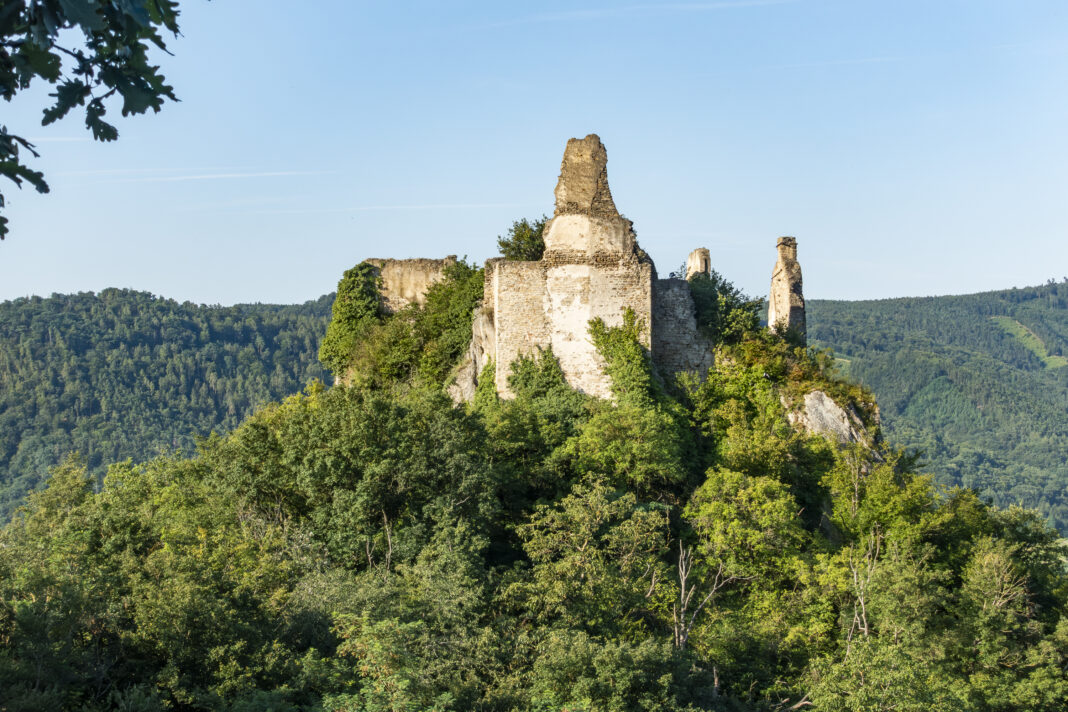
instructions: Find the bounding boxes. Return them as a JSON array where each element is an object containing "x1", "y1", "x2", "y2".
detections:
[{"x1": 0, "y1": 0, "x2": 178, "y2": 239}]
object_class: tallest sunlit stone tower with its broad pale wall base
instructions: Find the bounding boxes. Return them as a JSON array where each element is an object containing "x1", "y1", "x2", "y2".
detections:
[{"x1": 482, "y1": 133, "x2": 655, "y2": 398}]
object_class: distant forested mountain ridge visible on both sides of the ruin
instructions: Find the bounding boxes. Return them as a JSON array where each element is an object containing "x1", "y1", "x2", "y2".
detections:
[{"x1": 6, "y1": 283, "x2": 1068, "y2": 532}]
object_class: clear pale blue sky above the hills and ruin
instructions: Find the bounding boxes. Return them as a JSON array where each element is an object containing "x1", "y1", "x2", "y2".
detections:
[{"x1": 0, "y1": 0, "x2": 1068, "y2": 304}]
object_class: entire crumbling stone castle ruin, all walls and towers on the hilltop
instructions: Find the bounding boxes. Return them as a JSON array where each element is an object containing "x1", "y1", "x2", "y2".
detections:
[{"x1": 354, "y1": 135, "x2": 804, "y2": 401}]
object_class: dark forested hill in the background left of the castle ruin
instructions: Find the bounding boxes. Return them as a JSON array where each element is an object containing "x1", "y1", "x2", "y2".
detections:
[{"x1": 0, "y1": 289, "x2": 333, "y2": 520}]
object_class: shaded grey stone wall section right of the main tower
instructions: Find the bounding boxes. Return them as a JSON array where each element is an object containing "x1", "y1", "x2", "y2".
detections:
[{"x1": 653, "y1": 277, "x2": 712, "y2": 378}]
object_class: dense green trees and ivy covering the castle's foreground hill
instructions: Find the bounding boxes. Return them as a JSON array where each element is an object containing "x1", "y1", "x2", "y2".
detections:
[{"x1": 0, "y1": 255, "x2": 1068, "y2": 712}]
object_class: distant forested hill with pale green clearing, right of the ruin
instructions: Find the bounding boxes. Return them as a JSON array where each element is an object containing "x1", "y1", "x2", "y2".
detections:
[{"x1": 807, "y1": 281, "x2": 1068, "y2": 532}]
